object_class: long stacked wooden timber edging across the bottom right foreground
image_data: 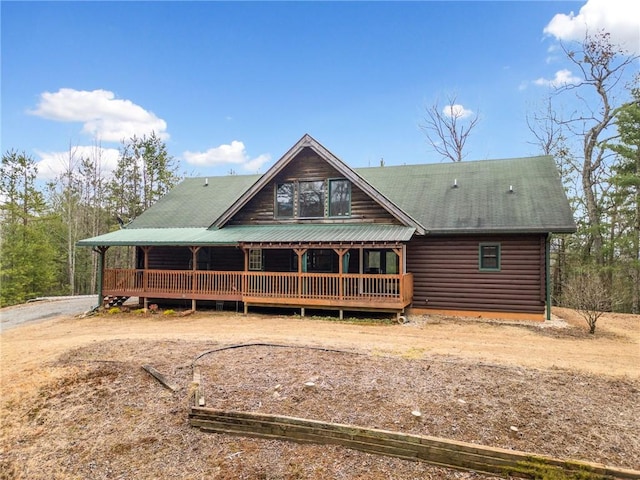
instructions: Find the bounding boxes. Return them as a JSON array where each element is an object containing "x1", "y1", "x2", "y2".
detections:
[{"x1": 189, "y1": 407, "x2": 640, "y2": 479}]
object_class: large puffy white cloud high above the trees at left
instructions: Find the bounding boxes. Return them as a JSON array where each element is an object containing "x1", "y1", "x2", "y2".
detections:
[{"x1": 29, "y1": 88, "x2": 169, "y2": 142}]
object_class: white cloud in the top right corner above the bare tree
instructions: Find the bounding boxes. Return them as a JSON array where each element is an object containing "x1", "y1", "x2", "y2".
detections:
[{"x1": 544, "y1": 0, "x2": 640, "y2": 53}]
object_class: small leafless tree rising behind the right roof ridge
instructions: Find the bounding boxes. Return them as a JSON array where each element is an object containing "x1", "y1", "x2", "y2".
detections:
[{"x1": 420, "y1": 95, "x2": 479, "y2": 162}]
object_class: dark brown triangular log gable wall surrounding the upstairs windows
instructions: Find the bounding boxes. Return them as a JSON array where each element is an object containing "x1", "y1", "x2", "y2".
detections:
[{"x1": 229, "y1": 148, "x2": 400, "y2": 225}]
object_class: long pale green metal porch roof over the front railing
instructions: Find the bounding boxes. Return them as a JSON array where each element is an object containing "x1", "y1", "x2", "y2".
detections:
[{"x1": 78, "y1": 224, "x2": 415, "y2": 246}]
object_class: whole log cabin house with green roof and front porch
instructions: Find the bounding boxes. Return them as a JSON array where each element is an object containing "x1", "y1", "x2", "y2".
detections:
[{"x1": 79, "y1": 135, "x2": 575, "y2": 320}]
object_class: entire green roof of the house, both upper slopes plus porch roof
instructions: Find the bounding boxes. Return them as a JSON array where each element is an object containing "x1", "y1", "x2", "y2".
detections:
[{"x1": 79, "y1": 145, "x2": 576, "y2": 245}]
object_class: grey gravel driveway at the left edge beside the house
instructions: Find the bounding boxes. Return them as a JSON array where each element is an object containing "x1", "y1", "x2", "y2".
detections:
[{"x1": 0, "y1": 295, "x2": 98, "y2": 331}]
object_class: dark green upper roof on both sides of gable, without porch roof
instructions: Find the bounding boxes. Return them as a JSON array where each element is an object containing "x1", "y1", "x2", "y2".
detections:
[{"x1": 127, "y1": 156, "x2": 575, "y2": 233}]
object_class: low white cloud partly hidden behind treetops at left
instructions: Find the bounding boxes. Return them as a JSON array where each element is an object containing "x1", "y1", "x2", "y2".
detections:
[{"x1": 36, "y1": 145, "x2": 120, "y2": 180}]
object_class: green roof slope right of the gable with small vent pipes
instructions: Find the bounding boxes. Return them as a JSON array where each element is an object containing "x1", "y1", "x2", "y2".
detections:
[{"x1": 355, "y1": 156, "x2": 575, "y2": 233}]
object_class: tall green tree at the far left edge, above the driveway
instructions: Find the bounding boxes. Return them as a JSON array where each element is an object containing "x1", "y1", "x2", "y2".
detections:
[{"x1": 0, "y1": 150, "x2": 57, "y2": 306}]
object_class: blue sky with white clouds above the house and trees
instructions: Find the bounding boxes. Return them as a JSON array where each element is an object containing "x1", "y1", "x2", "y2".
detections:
[{"x1": 1, "y1": 0, "x2": 640, "y2": 177}]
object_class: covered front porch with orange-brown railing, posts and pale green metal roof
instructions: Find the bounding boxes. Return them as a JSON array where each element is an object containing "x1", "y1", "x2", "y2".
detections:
[{"x1": 82, "y1": 225, "x2": 413, "y2": 316}]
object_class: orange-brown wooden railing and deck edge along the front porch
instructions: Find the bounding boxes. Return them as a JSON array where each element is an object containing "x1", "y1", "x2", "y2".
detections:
[{"x1": 102, "y1": 269, "x2": 413, "y2": 311}]
